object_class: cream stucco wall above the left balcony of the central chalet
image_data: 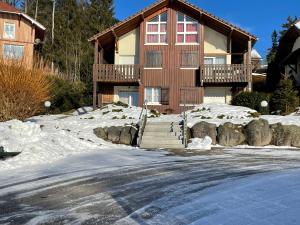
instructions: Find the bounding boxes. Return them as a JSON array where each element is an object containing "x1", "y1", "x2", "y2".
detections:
[{"x1": 115, "y1": 28, "x2": 140, "y2": 64}]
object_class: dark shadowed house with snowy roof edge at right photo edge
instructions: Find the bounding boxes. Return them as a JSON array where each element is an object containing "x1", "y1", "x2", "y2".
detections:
[{"x1": 276, "y1": 21, "x2": 300, "y2": 87}]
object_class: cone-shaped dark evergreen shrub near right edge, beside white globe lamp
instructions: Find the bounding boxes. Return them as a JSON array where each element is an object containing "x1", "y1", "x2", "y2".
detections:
[{"x1": 270, "y1": 79, "x2": 299, "y2": 114}]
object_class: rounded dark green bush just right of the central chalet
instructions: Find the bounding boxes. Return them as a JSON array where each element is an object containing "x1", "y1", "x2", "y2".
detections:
[{"x1": 232, "y1": 92, "x2": 270, "y2": 114}]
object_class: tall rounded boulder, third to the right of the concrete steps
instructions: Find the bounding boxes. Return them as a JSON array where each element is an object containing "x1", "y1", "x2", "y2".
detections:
[{"x1": 245, "y1": 119, "x2": 272, "y2": 146}]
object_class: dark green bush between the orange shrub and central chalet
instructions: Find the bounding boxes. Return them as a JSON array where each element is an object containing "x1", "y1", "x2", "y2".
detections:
[{"x1": 50, "y1": 77, "x2": 92, "y2": 113}]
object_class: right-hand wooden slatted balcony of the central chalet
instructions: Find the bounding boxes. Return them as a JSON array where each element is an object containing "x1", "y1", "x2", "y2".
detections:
[{"x1": 200, "y1": 64, "x2": 252, "y2": 83}]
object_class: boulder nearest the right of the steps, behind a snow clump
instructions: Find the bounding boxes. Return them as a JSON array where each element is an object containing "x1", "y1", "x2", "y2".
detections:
[{"x1": 191, "y1": 121, "x2": 217, "y2": 145}]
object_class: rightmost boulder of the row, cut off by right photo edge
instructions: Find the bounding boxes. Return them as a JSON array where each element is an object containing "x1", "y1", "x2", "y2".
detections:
[{"x1": 270, "y1": 123, "x2": 300, "y2": 147}]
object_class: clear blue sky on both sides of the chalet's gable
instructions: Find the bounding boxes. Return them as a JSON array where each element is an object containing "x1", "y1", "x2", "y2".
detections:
[{"x1": 115, "y1": 0, "x2": 300, "y2": 57}]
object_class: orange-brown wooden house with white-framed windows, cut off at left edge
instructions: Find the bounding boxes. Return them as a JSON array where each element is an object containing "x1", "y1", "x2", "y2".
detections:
[{"x1": 0, "y1": 1, "x2": 46, "y2": 66}]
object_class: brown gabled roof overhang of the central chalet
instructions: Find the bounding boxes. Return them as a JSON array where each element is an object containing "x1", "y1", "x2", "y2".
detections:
[{"x1": 88, "y1": 0, "x2": 258, "y2": 45}]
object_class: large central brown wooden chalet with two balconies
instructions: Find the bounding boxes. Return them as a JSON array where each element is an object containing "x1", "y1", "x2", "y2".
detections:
[{"x1": 89, "y1": 0, "x2": 257, "y2": 113}]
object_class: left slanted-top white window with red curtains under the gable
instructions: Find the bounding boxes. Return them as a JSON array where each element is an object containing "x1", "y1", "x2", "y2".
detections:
[{"x1": 146, "y1": 12, "x2": 168, "y2": 44}]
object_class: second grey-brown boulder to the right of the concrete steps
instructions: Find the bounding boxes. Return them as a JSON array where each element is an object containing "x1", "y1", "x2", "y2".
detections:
[{"x1": 218, "y1": 122, "x2": 246, "y2": 146}]
